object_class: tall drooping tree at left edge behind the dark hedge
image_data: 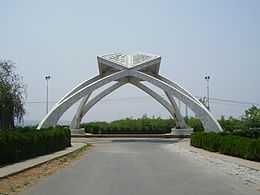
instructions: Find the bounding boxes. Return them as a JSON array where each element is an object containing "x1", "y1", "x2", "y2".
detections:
[{"x1": 0, "y1": 61, "x2": 25, "y2": 129}]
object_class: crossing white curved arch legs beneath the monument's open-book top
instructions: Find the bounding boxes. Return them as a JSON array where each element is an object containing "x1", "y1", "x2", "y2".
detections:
[{"x1": 38, "y1": 69, "x2": 222, "y2": 131}]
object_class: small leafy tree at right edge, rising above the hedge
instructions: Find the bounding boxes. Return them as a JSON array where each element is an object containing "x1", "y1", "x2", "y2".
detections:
[{"x1": 242, "y1": 105, "x2": 260, "y2": 129}]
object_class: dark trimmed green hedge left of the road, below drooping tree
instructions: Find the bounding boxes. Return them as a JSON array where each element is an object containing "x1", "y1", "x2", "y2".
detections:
[{"x1": 0, "y1": 128, "x2": 71, "y2": 165}]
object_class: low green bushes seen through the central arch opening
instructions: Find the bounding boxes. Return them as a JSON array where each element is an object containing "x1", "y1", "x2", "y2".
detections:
[{"x1": 81, "y1": 117, "x2": 175, "y2": 134}]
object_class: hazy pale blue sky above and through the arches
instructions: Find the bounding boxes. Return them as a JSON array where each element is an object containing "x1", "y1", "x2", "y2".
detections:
[{"x1": 0, "y1": 0, "x2": 260, "y2": 124}]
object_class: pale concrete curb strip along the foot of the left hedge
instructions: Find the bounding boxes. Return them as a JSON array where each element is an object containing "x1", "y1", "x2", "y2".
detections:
[{"x1": 0, "y1": 143, "x2": 87, "y2": 179}]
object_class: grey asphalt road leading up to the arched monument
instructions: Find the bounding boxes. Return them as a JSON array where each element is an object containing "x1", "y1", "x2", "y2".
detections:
[{"x1": 22, "y1": 139, "x2": 260, "y2": 195}]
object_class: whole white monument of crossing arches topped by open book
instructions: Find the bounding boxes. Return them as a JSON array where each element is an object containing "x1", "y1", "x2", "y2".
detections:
[{"x1": 38, "y1": 53, "x2": 222, "y2": 134}]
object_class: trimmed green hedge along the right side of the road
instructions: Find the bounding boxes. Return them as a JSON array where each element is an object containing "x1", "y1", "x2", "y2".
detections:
[{"x1": 191, "y1": 132, "x2": 260, "y2": 161}]
